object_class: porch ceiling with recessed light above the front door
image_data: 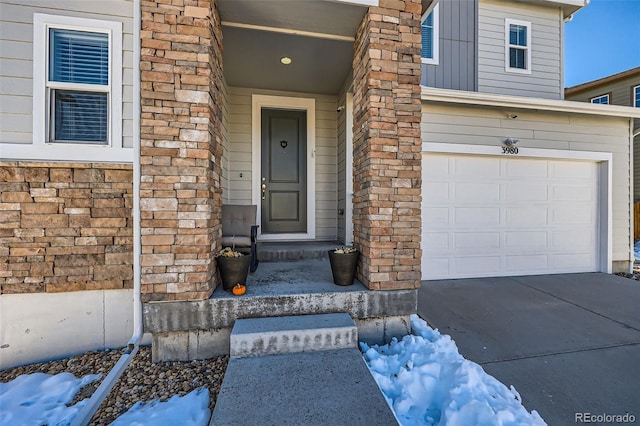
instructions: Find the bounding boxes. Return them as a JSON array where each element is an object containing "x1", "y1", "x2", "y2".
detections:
[{"x1": 219, "y1": 0, "x2": 366, "y2": 94}]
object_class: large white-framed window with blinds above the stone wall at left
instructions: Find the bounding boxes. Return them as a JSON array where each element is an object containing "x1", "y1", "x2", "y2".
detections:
[{"x1": 33, "y1": 14, "x2": 122, "y2": 146}]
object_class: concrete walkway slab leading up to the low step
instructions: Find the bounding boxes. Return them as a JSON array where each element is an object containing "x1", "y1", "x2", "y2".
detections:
[{"x1": 210, "y1": 348, "x2": 398, "y2": 426}]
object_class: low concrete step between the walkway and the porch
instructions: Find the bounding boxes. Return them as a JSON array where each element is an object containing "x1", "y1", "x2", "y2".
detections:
[{"x1": 230, "y1": 313, "x2": 358, "y2": 357}]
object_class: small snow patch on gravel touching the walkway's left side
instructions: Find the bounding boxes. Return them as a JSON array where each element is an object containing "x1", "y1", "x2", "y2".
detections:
[{"x1": 110, "y1": 388, "x2": 211, "y2": 426}]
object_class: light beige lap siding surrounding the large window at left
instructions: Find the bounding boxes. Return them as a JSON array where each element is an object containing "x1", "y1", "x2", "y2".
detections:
[{"x1": 0, "y1": 0, "x2": 133, "y2": 148}]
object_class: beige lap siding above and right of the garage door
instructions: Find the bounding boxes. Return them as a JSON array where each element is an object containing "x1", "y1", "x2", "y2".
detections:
[{"x1": 422, "y1": 103, "x2": 631, "y2": 270}]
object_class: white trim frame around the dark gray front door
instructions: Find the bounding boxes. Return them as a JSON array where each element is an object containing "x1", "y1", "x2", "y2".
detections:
[{"x1": 251, "y1": 95, "x2": 316, "y2": 241}]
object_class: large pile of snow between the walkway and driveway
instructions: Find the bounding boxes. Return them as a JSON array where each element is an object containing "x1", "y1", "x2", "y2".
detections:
[{"x1": 361, "y1": 315, "x2": 546, "y2": 426}]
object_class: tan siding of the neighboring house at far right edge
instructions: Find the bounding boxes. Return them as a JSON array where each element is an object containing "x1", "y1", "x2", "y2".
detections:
[{"x1": 567, "y1": 71, "x2": 640, "y2": 201}]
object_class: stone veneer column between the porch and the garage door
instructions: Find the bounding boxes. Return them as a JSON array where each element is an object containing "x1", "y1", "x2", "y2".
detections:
[{"x1": 353, "y1": 0, "x2": 422, "y2": 290}]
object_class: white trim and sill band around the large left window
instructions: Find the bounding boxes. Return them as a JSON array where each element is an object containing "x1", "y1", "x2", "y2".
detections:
[{"x1": 19, "y1": 13, "x2": 133, "y2": 162}]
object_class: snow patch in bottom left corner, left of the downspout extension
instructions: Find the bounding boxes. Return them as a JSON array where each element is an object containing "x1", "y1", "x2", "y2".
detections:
[{"x1": 0, "y1": 373, "x2": 100, "y2": 426}]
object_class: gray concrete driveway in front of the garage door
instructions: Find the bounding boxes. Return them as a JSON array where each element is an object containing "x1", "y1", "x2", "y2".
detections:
[{"x1": 418, "y1": 273, "x2": 640, "y2": 425}]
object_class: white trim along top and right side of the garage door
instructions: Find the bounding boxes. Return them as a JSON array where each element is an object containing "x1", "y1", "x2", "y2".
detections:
[{"x1": 422, "y1": 142, "x2": 613, "y2": 274}]
